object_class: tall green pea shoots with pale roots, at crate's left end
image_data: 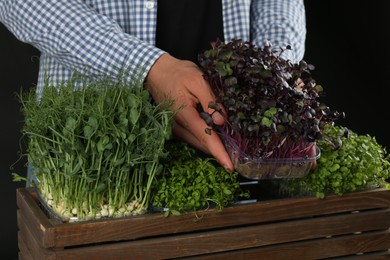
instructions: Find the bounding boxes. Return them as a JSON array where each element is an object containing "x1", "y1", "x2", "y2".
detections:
[{"x1": 15, "y1": 75, "x2": 174, "y2": 221}]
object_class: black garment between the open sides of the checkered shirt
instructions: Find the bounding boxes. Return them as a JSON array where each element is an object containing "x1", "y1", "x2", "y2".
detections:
[{"x1": 156, "y1": 0, "x2": 224, "y2": 63}]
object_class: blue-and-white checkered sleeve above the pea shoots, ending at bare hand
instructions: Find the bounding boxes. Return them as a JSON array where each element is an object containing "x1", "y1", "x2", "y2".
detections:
[{"x1": 0, "y1": 0, "x2": 163, "y2": 87}]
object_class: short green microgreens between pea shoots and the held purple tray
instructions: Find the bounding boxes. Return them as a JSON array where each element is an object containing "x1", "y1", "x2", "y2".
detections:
[{"x1": 153, "y1": 142, "x2": 249, "y2": 214}]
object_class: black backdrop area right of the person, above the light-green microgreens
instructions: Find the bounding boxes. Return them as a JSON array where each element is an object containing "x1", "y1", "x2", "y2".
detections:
[{"x1": 305, "y1": 0, "x2": 390, "y2": 149}]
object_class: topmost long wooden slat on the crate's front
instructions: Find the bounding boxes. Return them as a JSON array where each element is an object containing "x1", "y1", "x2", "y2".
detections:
[{"x1": 18, "y1": 188, "x2": 390, "y2": 248}]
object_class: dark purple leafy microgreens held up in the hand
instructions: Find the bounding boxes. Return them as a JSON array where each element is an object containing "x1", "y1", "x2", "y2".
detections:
[{"x1": 199, "y1": 39, "x2": 343, "y2": 159}]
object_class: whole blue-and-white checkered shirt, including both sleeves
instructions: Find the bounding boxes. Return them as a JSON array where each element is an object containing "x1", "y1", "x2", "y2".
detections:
[{"x1": 0, "y1": 0, "x2": 306, "y2": 92}]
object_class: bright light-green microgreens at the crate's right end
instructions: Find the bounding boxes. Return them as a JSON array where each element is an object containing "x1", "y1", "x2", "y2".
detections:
[{"x1": 290, "y1": 126, "x2": 390, "y2": 198}]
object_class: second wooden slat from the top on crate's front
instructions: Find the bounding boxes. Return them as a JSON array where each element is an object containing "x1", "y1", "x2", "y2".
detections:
[{"x1": 38, "y1": 209, "x2": 390, "y2": 259}]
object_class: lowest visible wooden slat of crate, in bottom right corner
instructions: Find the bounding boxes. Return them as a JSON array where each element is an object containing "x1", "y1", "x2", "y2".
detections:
[{"x1": 186, "y1": 230, "x2": 390, "y2": 260}]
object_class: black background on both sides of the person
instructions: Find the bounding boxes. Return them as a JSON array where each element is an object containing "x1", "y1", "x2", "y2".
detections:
[{"x1": 0, "y1": 0, "x2": 390, "y2": 259}]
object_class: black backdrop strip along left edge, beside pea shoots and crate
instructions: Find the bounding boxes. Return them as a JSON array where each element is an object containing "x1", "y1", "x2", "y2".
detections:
[{"x1": 0, "y1": 20, "x2": 38, "y2": 259}]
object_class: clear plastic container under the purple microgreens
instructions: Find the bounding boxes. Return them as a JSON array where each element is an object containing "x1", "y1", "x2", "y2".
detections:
[{"x1": 224, "y1": 139, "x2": 321, "y2": 180}]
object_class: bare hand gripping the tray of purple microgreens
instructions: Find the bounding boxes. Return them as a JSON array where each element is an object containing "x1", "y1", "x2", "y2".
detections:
[{"x1": 146, "y1": 54, "x2": 234, "y2": 171}]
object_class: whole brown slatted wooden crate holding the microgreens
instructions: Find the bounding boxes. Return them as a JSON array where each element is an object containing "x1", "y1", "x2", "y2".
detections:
[{"x1": 17, "y1": 188, "x2": 390, "y2": 260}]
